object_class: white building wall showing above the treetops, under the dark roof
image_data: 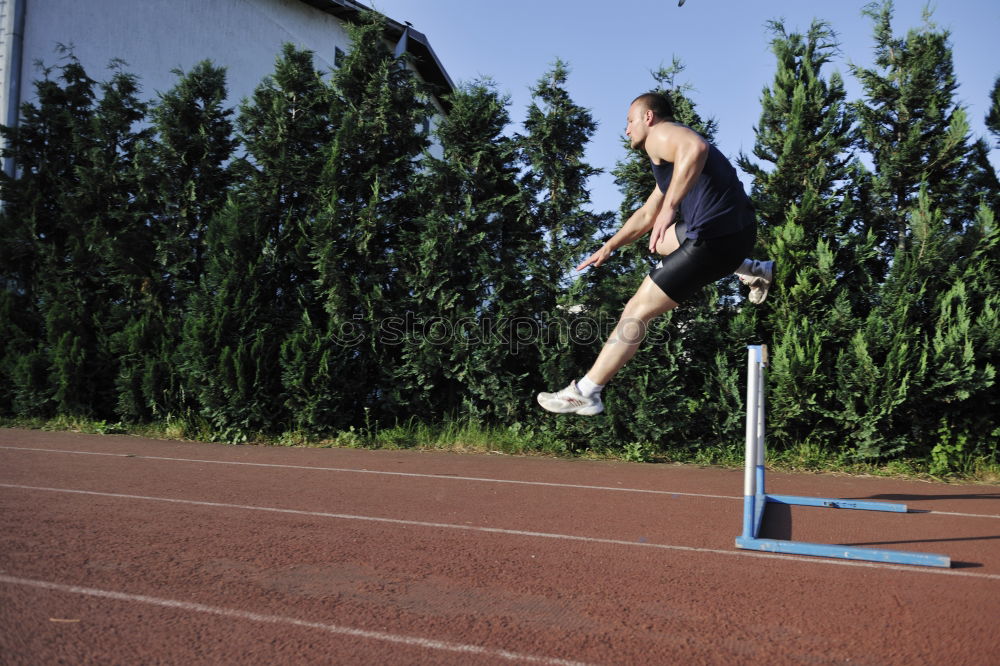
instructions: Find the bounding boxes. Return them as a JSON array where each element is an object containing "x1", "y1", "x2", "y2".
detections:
[{"x1": 16, "y1": 0, "x2": 350, "y2": 106}]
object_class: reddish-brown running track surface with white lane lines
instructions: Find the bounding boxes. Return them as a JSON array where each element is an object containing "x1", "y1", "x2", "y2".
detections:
[{"x1": 0, "y1": 429, "x2": 1000, "y2": 666}]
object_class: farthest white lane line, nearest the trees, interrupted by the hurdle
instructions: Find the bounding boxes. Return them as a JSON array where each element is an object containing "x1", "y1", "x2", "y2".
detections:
[{"x1": 0, "y1": 446, "x2": 1000, "y2": 519}]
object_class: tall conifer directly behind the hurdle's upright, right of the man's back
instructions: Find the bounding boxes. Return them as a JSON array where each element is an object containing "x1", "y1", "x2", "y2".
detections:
[{"x1": 739, "y1": 20, "x2": 871, "y2": 443}]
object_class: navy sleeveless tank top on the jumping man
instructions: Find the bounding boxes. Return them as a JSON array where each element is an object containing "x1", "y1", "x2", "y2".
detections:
[{"x1": 650, "y1": 144, "x2": 754, "y2": 238}]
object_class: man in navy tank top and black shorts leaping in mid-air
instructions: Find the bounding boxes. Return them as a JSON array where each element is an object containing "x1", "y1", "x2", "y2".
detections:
[{"x1": 538, "y1": 93, "x2": 774, "y2": 415}]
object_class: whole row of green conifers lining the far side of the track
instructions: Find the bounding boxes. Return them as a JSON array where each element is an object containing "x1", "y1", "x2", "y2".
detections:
[{"x1": 0, "y1": 7, "x2": 1000, "y2": 470}]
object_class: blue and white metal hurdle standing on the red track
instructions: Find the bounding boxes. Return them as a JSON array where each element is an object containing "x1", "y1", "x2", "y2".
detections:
[{"x1": 736, "y1": 345, "x2": 951, "y2": 567}]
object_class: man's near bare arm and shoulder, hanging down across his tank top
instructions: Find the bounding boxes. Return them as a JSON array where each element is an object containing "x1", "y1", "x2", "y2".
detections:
[{"x1": 646, "y1": 123, "x2": 708, "y2": 252}]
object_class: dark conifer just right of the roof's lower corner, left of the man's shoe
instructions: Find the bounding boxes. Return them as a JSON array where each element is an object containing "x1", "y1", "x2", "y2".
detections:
[{"x1": 395, "y1": 80, "x2": 537, "y2": 420}]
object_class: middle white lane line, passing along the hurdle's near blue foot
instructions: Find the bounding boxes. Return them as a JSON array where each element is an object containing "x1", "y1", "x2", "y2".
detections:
[{"x1": 0, "y1": 483, "x2": 1000, "y2": 580}]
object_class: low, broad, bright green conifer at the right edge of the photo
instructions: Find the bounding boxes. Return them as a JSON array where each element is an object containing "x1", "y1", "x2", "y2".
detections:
[{"x1": 836, "y1": 188, "x2": 1000, "y2": 460}]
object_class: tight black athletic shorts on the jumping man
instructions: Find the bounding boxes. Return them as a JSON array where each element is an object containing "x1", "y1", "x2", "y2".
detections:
[{"x1": 649, "y1": 217, "x2": 757, "y2": 303}]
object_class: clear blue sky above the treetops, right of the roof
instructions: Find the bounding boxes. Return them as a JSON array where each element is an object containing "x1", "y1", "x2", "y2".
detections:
[{"x1": 370, "y1": 0, "x2": 1000, "y2": 211}]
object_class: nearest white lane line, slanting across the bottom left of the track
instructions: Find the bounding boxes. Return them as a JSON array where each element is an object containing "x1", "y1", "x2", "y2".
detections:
[{"x1": 0, "y1": 574, "x2": 580, "y2": 666}]
